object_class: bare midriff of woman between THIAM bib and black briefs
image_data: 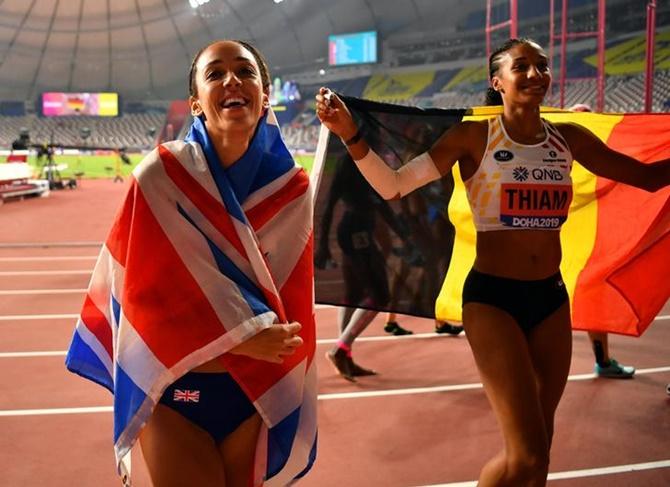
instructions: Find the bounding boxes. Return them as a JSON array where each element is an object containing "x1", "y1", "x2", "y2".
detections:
[{"x1": 474, "y1": 230, "x2": 561, "y2": 280}]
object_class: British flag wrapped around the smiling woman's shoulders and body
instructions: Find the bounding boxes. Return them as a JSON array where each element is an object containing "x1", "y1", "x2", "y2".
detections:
[{"x1": 66, "y1": 111, "x2": 317, "y2": 486}]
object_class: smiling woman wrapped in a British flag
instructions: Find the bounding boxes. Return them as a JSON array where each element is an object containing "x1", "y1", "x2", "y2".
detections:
[{"x1": 67, "y1": 41, "x2": 316, "y2": 487}]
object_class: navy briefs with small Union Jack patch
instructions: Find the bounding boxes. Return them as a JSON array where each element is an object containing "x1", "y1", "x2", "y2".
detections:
[{"x1": 159, "y1": 372, "x2": 256, "y2": 445}]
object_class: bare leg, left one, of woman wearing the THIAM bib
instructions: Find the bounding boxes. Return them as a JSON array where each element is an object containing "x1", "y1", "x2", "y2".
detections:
[{"x1": 463, "y1": 302, "x2": 549, "y2": 487}]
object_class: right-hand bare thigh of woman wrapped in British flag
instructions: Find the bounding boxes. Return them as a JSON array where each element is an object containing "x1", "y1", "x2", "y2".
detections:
[{"x1": 219, "y1": 413, "x2": 262, "y2": 487}]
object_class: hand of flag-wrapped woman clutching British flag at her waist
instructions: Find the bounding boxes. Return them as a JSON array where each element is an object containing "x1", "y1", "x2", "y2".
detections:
[{"x1": 230, "y1": 321, "x2": 303, "y2": 364}]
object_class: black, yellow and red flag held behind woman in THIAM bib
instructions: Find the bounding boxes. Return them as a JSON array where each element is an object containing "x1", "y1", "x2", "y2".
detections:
[{"x1": 312, "y1": 97, "x2": 670, "y2": 336}]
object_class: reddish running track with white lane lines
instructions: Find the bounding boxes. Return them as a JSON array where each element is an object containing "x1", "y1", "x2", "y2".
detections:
[{"x1": 0, "y1": 180, "x2": 670, "y2": 487}]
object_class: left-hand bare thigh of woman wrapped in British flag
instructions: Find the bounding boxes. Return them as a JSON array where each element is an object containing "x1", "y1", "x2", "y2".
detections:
[{"x1": 140, "y1": 404, "x2": 226, "y2": 487}]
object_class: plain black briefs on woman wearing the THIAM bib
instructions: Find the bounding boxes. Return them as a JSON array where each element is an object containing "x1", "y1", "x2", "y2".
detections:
[{"x1": 463, "y1": 269, "x2": 568, "y2": 334}]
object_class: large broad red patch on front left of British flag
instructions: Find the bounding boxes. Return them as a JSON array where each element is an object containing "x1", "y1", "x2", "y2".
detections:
[{"x1": 121, "y1": 186, "x2": 231, "y2": 367}]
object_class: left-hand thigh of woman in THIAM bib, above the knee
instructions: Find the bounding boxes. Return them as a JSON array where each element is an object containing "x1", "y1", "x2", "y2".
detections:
[{"x1": 463, "y1": 302, "x2": 547, "y2": 454}]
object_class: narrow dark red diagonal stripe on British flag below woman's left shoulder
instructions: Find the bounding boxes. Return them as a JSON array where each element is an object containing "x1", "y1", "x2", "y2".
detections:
[{"x1": 158, "y1": 145, "x2": 249, "y2": 260}]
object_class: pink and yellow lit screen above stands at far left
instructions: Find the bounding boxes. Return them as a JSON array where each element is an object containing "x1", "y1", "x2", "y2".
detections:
[{"x1": 42, "y1": 93, "x2": 119, "y2": 117}]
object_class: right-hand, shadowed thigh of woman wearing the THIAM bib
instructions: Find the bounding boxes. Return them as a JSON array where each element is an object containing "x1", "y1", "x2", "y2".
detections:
[{"x1": 528, "y1": 301, "x2": 572, "y2": 438}]
